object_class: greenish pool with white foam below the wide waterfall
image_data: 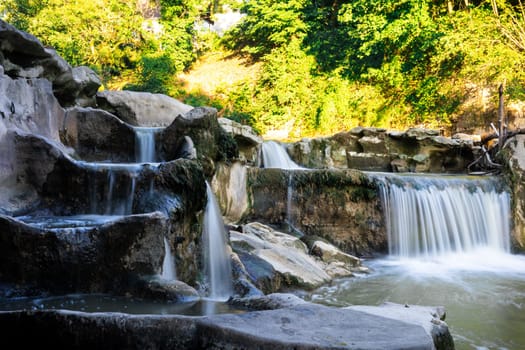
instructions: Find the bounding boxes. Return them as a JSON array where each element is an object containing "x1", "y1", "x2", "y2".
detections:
[{"x1": 303, "y1": 254, "x2": 525, "y2": 350}]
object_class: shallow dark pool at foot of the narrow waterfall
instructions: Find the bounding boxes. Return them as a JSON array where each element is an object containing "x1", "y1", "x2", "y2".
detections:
[{"x1": 0, "y1": 294, "x2": 245, "y2": 316}]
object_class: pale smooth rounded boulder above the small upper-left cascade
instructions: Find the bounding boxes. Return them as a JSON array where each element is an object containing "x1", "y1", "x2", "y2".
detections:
[{"x1": 96, "y1": 91, "x2": 193, "y2": 127}]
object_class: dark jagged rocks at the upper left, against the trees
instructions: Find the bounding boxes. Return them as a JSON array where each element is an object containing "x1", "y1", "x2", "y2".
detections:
[{"x1": 0, "y1": 20, "x2": 101, "y2": 106}]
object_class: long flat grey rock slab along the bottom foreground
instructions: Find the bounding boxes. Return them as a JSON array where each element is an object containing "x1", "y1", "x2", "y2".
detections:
[{"x1": 0, "y1": 303, "x2": 454, "y2": 350}]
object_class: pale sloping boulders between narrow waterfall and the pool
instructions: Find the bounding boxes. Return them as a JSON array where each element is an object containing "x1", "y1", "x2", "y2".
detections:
[{"x1": 230, "y1": 223, "x2": 366, "y2": 293}]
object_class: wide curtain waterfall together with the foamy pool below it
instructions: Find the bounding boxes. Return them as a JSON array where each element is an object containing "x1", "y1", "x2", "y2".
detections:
[{"x1": 304, "y1": 174, "x2": 525, "y2": 349}]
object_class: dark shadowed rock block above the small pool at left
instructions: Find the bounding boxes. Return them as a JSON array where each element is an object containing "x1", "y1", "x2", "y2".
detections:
[{"x1": 0, "y1": 213, "x2": 168, "y2": 293}]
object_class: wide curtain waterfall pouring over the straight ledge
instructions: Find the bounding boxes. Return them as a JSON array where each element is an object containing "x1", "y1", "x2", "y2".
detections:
[{"x1": 372, "y1": 174, "x2": 510, "y2": 258}]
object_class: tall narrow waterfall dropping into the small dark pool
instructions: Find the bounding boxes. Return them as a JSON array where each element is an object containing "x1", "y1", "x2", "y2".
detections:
[{"x1": 202, "y1": 182, "x2": 233, "y2": 300}]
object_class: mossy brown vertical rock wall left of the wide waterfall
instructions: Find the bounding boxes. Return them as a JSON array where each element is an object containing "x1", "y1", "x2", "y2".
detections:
[{"x1": 245, "y1": 168, "x2": 387, "y2": 256}]
